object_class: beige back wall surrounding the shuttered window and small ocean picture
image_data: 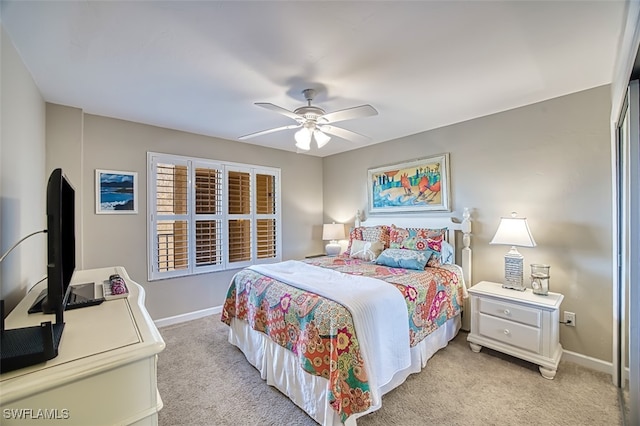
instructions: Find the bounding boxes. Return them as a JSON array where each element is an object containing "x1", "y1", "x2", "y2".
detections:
[{"x1": 47, "y1": 108, "x2": 322, "y2": 320}]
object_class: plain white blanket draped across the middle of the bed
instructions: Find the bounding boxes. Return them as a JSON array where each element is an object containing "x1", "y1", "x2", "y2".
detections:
[{"x1": 249, "y1": 260, "x2": 411, "y2": 407}]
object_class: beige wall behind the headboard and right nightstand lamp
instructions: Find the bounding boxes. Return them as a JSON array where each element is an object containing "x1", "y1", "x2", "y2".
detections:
[{"x1": 323, "y1": 86, "x2": 613, "y2": 362}]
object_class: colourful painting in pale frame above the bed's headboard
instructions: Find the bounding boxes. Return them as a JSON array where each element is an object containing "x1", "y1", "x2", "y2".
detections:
[{"x1": 367, "y1": 154, "x2": 450, "y2": 213}]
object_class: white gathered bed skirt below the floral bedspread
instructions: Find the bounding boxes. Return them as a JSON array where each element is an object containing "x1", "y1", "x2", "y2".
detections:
[{"x1": 229, "y1": 315, "x2": 460, "y2": 426}]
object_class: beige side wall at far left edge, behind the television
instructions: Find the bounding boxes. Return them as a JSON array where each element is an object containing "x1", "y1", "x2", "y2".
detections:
[{"x1": 0, "y1": 27, "x2": 48, "y2": 311}]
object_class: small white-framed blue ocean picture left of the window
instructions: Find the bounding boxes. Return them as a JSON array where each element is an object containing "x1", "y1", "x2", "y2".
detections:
[{"x1": 96, "y1": 169, "x2": 138, "y2": 214}]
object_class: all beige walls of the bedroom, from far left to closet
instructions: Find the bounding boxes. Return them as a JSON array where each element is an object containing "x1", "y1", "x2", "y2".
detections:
[{"x1": 0, "y1": 21, "x2": 613, "y2": 361}]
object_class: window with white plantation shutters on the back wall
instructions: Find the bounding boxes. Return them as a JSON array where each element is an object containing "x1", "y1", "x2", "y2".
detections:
[{"x1": 147, "y1": 153, "x2": 282, "y2": 280}]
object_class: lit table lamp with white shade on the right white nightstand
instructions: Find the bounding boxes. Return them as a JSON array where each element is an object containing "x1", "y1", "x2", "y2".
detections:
[{"x1": 489, "y1": 212, "x2": 536, "y2": 291}]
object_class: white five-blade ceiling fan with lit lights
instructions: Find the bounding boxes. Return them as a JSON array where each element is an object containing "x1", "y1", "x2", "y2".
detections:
[{"x1": 238, "y1": 89, "x2": 378, "y2": 151}]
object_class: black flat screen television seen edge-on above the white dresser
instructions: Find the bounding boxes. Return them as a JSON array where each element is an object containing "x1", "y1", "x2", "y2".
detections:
[{"x1": 42, "y1": 169, "x2": 76, "y2": 322}]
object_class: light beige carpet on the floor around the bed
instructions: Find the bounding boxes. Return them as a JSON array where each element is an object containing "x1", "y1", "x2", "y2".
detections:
[{"x1": 158, "y1": 315, "x2": 622, "y2": 426}]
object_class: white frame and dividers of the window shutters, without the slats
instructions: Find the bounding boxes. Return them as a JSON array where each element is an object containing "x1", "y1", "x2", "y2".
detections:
[{"x1": 147, "y1": 152, "x2": 282, "y2": 281}]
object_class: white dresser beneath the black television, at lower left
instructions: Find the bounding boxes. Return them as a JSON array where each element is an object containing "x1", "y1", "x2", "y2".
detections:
[{"x1": 0, "y1": 267, "x2": 165, "y2": 426}]
